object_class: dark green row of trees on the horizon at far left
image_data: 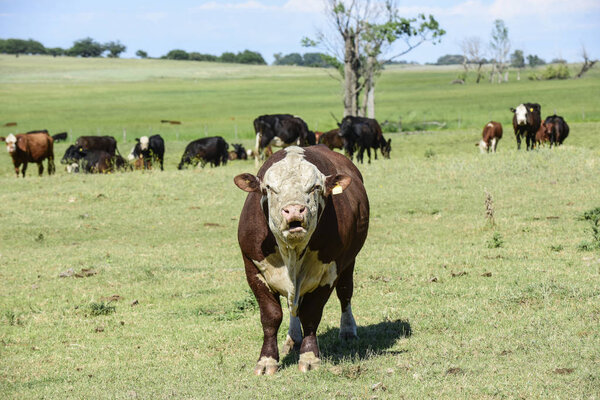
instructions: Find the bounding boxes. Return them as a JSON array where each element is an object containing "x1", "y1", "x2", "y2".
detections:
[{"x1": 0, "y1": 37, "x2": 127, "y2": 58}]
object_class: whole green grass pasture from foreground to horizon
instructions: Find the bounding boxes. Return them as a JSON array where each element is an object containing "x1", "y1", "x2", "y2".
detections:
[{"x1": 0, "y1": 56, "x2": 600, "y2": 399}]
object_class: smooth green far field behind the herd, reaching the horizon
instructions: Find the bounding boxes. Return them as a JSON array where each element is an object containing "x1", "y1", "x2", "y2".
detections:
[{"x1": 0, "y1": 55, "x2": 600, "y2": 140}]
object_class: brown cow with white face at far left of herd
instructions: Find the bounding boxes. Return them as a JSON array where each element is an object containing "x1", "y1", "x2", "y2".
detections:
[{"x1": 5, "y1": 133, "x2": 55, "y2": 178}]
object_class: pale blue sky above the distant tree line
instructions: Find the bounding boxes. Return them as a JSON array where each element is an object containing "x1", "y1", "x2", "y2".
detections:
[{"x1": 0, "y1": 0, "x2": 600, "y2": 63}]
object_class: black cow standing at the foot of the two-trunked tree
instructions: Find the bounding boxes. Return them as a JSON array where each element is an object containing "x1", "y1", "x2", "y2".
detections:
[{"x1": 339, "y1": 116, "x2": 392, "y2": 163}]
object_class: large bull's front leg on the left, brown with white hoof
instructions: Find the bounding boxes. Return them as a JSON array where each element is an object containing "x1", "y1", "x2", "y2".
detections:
[{"x1": 244, "y1": 256, "x2": 283, "y2": 375}]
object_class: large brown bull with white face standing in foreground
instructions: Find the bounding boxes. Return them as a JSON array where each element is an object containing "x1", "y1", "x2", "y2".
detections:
[{"x1": 234, "y1": 145, "x2": 369, "y2": 375}]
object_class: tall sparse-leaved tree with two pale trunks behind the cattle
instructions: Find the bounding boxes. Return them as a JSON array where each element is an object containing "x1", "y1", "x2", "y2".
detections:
[{"x1": 303, "y1": 0, "x2": 445, "y2": 117}]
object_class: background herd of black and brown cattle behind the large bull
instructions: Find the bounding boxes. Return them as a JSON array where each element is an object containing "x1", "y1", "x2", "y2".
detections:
[{"x1": 0, "y1": 103, "x2": 569, "y2": 177}]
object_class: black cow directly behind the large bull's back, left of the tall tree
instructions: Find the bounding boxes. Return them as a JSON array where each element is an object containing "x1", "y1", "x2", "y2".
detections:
[{"x1": 254, "y1": 114, "x2": 316, "y2": 163}]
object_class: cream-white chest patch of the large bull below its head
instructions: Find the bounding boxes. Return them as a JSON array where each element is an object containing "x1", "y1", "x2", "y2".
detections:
[{"x1": 252, "y1": 247, "x2": 337, "y2": 316}]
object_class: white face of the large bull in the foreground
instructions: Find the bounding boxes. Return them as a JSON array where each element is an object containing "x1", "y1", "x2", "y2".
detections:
[{"x1": 261, "y1": 147, "x2": 327, "y2": 247}]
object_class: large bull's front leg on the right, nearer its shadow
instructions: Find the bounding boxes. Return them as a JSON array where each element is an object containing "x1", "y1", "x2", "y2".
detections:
[{"x1": 298, "y1": 285, "x2": 333, "y2": 372}]
